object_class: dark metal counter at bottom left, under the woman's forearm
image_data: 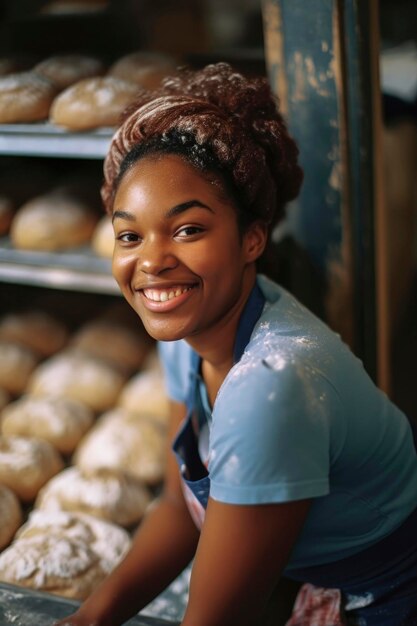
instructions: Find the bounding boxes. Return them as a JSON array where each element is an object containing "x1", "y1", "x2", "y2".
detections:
[{"x1": 0, "y1": 583, "x2": 174, "y2": 626}]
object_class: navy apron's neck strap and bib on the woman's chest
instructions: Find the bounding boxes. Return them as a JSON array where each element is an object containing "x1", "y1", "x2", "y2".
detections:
[{"x1": 172, "y1": 283, "x2": 265, "y2": 529}]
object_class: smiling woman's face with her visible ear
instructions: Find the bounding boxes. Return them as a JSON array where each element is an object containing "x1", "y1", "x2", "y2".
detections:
[{"x1": 113, "y1": 155, "x2": 262, "y2": 341}]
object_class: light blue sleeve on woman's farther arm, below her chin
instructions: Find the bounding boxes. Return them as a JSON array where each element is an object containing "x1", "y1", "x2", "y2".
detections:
[{"x1": 157, "y1": 341, "x2": 192, "y2": 403}]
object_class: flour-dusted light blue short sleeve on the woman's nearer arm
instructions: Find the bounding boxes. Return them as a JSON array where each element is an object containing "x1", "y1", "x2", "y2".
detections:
[{"x1": 209, "y1": 360, "x2": 333, "y2": 504}]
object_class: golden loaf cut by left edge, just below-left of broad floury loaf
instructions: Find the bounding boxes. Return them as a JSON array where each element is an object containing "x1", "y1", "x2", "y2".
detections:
[{"x1": 1, "y1": 395, "x2": 94, "y2": 455}]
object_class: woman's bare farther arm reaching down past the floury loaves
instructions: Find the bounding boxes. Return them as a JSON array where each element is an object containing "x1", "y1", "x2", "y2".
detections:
[{"x1": 57, "y1": 403, "x2": 199, "y2": 626}]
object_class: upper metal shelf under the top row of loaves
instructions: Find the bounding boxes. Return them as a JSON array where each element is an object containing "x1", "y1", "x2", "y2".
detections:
[{"x1": 0, "y1": 122, "x2": 114, "y2": 159}]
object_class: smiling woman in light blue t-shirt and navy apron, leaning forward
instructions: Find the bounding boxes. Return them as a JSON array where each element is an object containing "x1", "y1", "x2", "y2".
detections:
[{"x1": 56, "y1": 63, "x2": 417, "y2": 626}]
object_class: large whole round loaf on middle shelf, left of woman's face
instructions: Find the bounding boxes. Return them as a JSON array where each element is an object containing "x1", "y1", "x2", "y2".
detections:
[{"x1": 10, "y1": 191, "x2": 98, "y2": 251}]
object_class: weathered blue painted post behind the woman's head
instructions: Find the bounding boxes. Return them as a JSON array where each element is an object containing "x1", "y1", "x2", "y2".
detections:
[{"x1": 262, "y1": 0, "x2": 376, "y2": 376}]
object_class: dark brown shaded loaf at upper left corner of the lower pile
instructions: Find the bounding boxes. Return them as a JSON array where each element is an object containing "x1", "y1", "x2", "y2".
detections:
[{"x1": 0, "y1": 311, "x2": 68, "y2": 357}]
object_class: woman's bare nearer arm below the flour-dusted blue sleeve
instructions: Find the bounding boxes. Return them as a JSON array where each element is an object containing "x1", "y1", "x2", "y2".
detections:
[{"x1": 182, "y1": 492, "x2": 310, "y2": 626}]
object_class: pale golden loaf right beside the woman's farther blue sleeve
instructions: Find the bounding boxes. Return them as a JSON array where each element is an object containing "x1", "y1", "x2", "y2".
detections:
[{"x1": 117, "y1": 369, "x2": 169, "y2": 426}]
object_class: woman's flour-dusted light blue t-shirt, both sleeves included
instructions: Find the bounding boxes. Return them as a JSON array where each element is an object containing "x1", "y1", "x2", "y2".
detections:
[{"x1": 159, "y1": 276, "x2": 417, "y2": 573}]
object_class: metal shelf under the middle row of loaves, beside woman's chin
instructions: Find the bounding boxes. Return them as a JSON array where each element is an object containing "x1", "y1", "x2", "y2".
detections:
[{"x1": 0, "y1": 237, "x2": 120, "y2": 295}]
